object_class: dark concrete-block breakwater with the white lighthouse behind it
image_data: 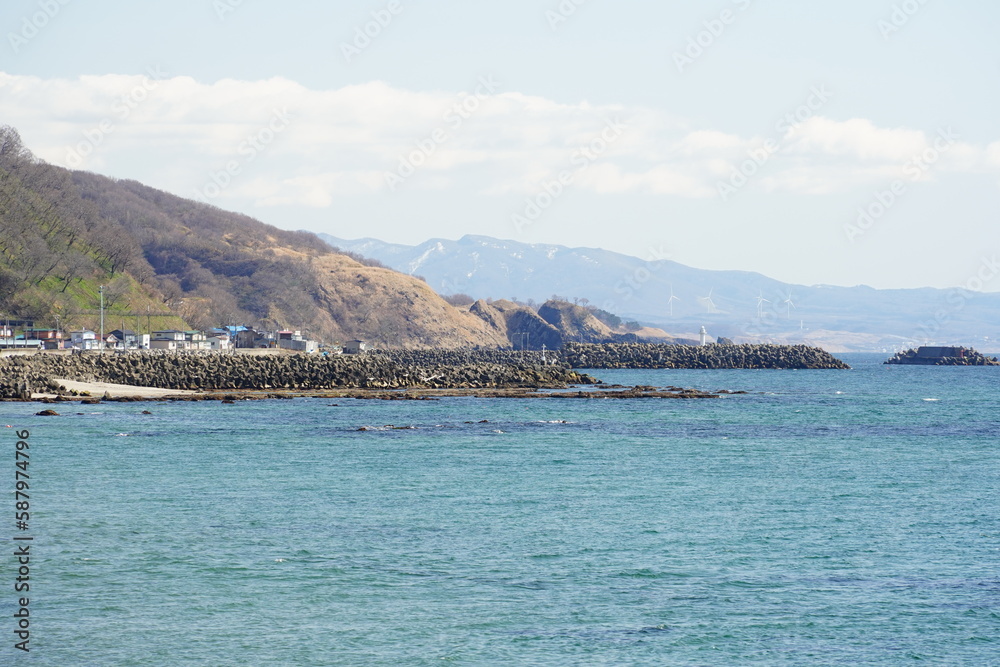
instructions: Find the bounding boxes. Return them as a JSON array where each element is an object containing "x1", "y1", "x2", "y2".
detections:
[{"x1": 559, "y1": 343, "x2": 850, "y2": 369}]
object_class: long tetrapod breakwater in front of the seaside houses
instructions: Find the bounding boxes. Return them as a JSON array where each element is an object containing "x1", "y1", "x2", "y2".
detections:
[{"x1": 0, "y1": 351, "x2": 596, "y2": 399}]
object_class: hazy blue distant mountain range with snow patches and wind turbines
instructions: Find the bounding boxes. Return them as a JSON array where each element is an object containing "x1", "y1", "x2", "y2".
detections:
[{"x1": 319, "y1": 234, "x2": 1000, "y2": 351}]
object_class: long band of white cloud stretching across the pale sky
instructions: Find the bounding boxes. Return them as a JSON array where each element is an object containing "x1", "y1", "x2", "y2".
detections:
[{"x1": 0, "y1": 72, "x2": 1000, "y2": 208}]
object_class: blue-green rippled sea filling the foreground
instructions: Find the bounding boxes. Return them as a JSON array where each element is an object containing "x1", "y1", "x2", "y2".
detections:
[{"x1": 0, "y1": 355, "x2": 1000, "y2": 667}]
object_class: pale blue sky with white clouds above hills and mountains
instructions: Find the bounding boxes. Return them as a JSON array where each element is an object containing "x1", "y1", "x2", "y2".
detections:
[{"x1": 0, "y1": 0, "x2": 1000, "y2": 291}]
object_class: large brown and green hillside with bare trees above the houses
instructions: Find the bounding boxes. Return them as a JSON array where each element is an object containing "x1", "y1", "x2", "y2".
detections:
[{"x1": 0, "y1": 127, "x2": 508, "y2": 347}]
